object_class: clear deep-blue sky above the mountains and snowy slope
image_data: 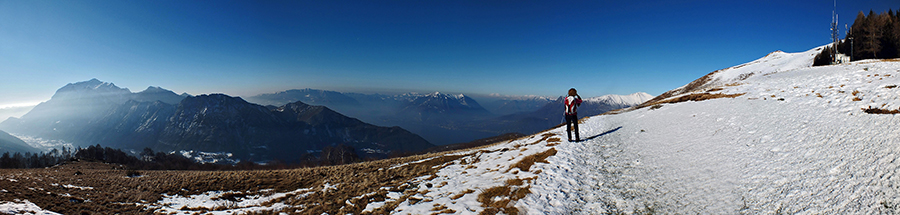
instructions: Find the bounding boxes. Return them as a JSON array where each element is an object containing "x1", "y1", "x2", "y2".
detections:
[{"x1": 0, "y1": 0, "x2": 900, "y2": 106}]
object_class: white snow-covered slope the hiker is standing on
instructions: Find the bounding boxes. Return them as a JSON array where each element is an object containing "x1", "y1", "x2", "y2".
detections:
[{"x1": 358, "y1": 47, "x2": 900, "y2": 214}]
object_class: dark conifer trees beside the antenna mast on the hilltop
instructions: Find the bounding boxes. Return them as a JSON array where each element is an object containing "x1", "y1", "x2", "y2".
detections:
[{"x1": 813, "y1": 10, "x2": 900, "y2": 66}]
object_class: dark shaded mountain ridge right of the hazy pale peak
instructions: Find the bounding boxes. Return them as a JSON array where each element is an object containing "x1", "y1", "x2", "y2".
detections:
[{"x1": 155, "y1": 94, "x2": 432, "y2": 160}]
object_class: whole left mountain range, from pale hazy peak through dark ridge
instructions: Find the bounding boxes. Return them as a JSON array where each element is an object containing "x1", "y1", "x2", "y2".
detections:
[{"x1": 0, "y1": 79, "x2": 433, "y2": 161}]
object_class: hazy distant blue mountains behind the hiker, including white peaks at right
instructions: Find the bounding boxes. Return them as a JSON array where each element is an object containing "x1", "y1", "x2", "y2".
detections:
[{"x1": 247, "y1": 89, "x2": 652, "y2": 145}]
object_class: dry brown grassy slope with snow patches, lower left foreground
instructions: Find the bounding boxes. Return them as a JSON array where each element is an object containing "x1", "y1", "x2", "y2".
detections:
[{"x1": 0, "y1": 149, "x2": 474, "y2": 214}]
